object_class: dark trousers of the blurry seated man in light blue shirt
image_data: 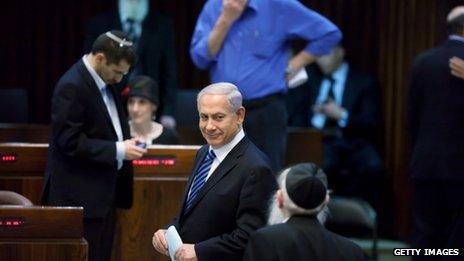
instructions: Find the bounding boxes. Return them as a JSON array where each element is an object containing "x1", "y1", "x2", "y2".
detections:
[{"x1": 322, "y1": 137, "x2": 384, "y2": 210}]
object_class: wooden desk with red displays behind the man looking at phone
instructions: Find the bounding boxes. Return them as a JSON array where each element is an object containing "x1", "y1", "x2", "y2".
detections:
[{"x1": 0, "y1": 143, "x2": 199, "y2": 260}]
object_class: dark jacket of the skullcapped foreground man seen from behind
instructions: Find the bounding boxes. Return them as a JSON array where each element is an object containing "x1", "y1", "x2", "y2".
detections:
[{"x1": 243, "y1": 216, "x2": 364, "y2": 261}]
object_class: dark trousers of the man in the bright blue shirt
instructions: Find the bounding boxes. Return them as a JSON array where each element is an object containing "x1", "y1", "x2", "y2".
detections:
[{"x1": 243, "y1": 94, "x2": 287, "y2": 173}]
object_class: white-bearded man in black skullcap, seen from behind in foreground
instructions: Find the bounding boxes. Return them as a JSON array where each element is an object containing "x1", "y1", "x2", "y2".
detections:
[{"x1": 243, "y1": 163, "x2": 364, "y2": 261}]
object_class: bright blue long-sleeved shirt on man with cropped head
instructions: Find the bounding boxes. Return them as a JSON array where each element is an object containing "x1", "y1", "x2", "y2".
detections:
[{"x1": 190, "y1": 0, "x2": 341, "y2": 100}]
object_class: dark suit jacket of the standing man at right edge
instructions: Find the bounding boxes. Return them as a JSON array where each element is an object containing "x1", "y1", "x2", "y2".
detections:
[{"x1": 407, "y1": 40, "x2": 464, "y2": 180}]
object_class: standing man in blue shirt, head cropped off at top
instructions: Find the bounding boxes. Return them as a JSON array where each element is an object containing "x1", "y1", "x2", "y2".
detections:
[{"x1": 190, "y1": 0, "x2": 341, "y2": 170}]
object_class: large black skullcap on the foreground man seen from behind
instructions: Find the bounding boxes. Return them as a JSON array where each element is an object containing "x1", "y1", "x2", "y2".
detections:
[{"x1": 285, "y1": 163, "x2": 327, "y2": 209}]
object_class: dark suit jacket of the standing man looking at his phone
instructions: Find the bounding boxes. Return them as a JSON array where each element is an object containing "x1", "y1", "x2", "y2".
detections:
[{"x1": 43, "y1": 59, "x2": 133, "y2": 218}]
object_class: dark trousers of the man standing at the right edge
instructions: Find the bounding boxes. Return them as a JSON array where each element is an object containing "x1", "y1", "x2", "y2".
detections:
[{"x1": 411, "y1": 179, "x2": 464, "y2": 260}]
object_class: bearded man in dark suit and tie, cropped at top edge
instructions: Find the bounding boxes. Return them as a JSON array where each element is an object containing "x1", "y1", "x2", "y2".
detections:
[{"x1": 84, "y1": 0, "x2": 177, "y2": 128}]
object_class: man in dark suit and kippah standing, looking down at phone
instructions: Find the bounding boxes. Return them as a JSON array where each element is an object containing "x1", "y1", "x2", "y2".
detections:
[{"x1": 43, "y1": 31, "x2": 145, "y2": 260}]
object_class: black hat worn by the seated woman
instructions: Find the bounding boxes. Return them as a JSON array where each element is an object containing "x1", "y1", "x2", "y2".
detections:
[{"x1": 128, "y1": 75, "x2": 159, "y2": 106}]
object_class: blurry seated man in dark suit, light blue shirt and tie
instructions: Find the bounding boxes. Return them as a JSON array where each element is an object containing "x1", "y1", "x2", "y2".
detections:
[{"x1": 287, "y1": 45, "x2": 384, "y2": 206}]
